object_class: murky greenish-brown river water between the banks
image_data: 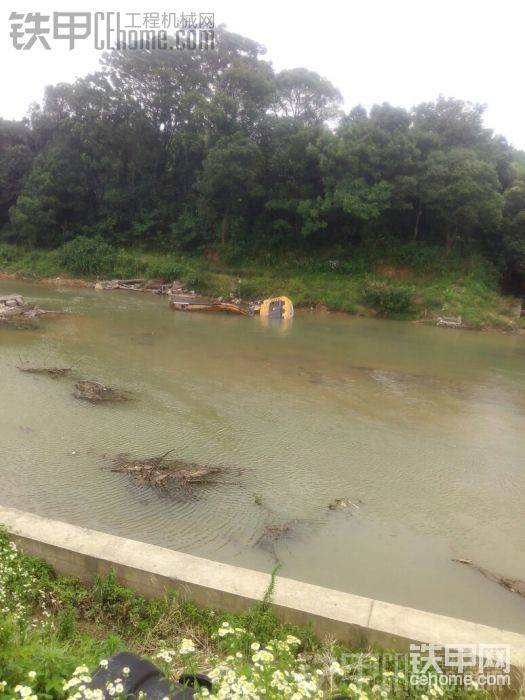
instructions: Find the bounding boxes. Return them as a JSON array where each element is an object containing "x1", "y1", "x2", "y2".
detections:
[{"x1": 0, "y1": 281, "x2": 525, "y2": 632}]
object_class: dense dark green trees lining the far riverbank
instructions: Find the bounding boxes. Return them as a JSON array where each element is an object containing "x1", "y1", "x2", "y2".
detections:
[{"x1": 0, "y1": 29, "x2": 525, "y2": 290}]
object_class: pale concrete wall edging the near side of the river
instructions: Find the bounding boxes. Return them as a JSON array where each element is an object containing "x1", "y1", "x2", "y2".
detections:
[{"x1": 0, "y1": 506, "x2": 525, "y2": 667}]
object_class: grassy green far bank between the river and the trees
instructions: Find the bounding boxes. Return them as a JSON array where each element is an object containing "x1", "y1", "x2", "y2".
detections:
[{"x1": 0, "y1": 239, "x2": 524, "y2": 331}]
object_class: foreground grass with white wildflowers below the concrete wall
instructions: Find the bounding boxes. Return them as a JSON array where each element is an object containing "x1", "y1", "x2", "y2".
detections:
[{"x1": 0, "y1": 530, "x2": 504, "y2": 700}]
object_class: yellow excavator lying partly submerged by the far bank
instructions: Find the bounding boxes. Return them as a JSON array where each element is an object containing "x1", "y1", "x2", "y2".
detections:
[{"x1": 170, "y1": 294, "x2": 294, "y2": 320}]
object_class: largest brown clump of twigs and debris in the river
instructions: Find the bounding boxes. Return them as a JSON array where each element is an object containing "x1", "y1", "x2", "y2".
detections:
[{"x1": 111, "y1": 450, "x2": 240, "y2": 491}]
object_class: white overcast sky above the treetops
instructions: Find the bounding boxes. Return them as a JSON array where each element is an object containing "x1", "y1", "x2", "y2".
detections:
[{"x1": 0, "y1": 0, "x2": 525, "y2": 149}]
